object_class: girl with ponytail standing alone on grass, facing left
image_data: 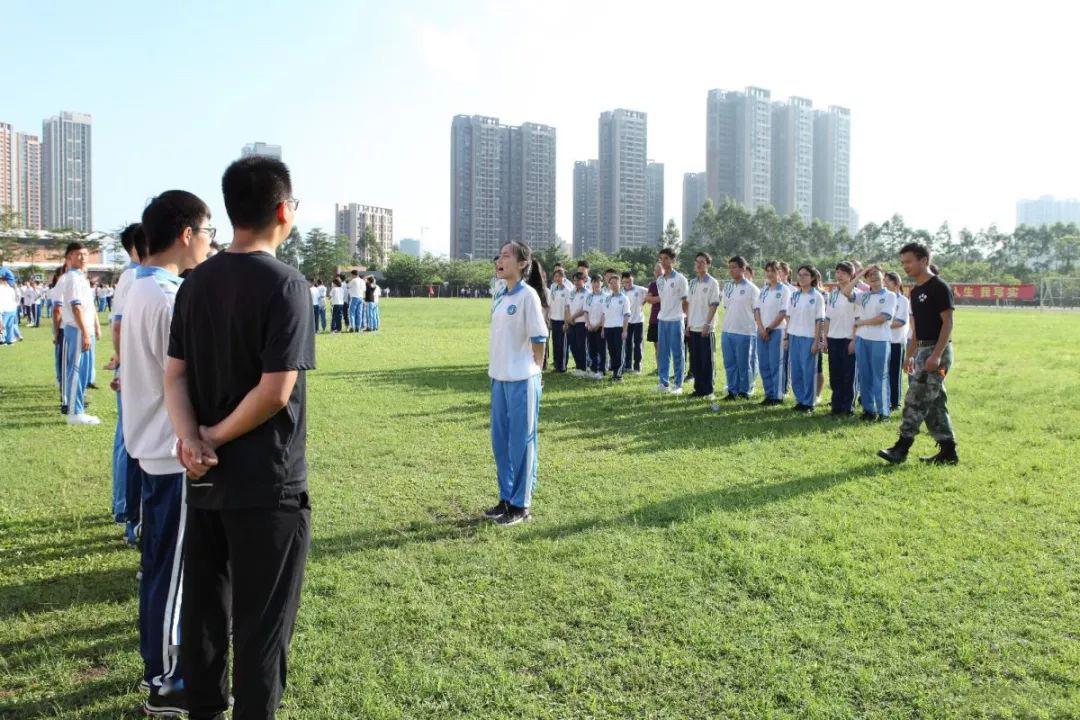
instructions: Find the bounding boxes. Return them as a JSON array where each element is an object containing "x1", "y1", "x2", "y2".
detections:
[{"x1": 484, "y1": 242, "x2": 548, "y2": 526}]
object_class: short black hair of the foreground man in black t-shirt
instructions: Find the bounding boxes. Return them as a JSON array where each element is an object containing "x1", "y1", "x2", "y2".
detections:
[{"x1": 221, "y1": 155, "x2": 293, "y2": 230}]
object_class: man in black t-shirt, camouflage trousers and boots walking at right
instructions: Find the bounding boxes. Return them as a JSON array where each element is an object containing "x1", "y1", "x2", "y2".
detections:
[{"x1": 878, "y1": 243, "x2": 960, "y2": 465}]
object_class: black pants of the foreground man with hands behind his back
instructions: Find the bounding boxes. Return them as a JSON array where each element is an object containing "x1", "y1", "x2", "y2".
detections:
[{"x1": 180, "y1": 492, "x2": 311, "y2": 720}]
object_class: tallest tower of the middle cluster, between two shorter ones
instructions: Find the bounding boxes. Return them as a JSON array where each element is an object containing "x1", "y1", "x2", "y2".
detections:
[{"x1": 598, "y1": 109, "x2": 649, "y2": 253}]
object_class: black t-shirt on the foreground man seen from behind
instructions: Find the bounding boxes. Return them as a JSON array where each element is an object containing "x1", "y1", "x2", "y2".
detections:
[{"x1": 168, "y1": 253, "x2": 315, "y2": 510}]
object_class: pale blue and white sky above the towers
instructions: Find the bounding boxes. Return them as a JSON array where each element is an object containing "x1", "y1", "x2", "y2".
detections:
[{"x1": 0, "y1": 0, "x2": 1080, "y2": 255}]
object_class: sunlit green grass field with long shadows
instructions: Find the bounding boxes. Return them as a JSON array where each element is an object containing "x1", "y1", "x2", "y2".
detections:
[{"x1": 0, "y1": 299, "x2": 1080, "y2": 720}]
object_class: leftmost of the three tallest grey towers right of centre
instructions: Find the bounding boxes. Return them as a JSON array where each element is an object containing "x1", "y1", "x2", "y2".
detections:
[{"x1": 705, "y1": 87, "x2": 772, "y2": 210}]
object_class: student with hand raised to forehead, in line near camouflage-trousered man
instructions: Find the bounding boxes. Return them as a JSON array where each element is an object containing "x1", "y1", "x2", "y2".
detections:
[{"x1": 845, "y1": 266, "x2": 896, "y2": 422}]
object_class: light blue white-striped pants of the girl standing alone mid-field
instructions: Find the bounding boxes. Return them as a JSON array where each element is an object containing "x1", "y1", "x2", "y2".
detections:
[{"x1": 491, "y1": 375, "x2": 541, "y2": 507}]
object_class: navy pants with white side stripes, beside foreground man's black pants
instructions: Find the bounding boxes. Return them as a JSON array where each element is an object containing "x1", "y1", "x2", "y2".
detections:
[{"x1": 138, "y1": 473, "x2": 187, "y2": 688}]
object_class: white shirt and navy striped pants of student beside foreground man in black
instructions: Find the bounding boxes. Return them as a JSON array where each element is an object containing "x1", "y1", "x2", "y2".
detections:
[{"x1": 120, "y1": 267, "x2": 187, "y2": 692}]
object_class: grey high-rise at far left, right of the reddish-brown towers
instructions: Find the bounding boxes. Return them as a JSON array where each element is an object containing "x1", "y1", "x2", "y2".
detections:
[{"x1": 41, "y1": 112, "x2": 94, "y2": 232}]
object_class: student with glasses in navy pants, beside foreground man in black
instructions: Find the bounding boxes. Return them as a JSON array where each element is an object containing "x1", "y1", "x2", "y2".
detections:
[{"x1": 120, "y1": 190, "x2": 216, "y2": 716}]
